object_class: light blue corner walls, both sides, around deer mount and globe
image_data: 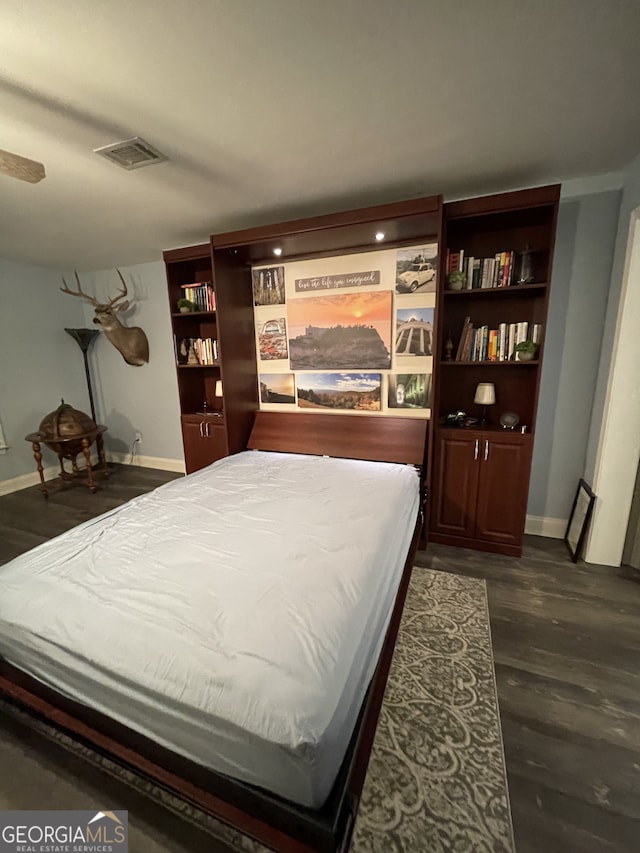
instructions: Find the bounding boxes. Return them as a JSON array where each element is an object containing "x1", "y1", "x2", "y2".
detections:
[{"x1": 0, "y1": 259, "x2": 183, "y2": 481}]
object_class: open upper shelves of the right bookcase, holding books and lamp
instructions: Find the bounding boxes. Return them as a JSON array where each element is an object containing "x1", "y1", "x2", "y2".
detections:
[{"x1": 434, "y1": 187, "x2": 557, "y2": 432}]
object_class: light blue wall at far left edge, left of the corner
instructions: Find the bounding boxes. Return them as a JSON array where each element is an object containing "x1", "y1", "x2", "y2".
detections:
[{"x1": 0, "y1": 259, "x2": 89, "y2": 481}]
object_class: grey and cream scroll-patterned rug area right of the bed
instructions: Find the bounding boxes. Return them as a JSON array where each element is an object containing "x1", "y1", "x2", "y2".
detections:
[{"x1": 352, "y1": 568, "x2": 515, "y2": 853}]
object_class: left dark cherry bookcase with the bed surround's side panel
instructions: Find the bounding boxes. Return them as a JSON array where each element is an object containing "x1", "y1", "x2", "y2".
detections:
[{"x1": 163, "y1": 243, "x2": 258, "y2": 474}]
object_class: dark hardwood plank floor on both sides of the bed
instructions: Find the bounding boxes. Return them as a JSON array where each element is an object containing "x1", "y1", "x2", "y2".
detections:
[{"x1": 0, "y1": 466, "x2": 640, "y2": 853}]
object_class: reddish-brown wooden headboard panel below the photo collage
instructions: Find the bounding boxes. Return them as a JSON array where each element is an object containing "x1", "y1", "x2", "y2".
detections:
[{"x1": 247, "y1": 411, "x2": 427, "y2": 466}]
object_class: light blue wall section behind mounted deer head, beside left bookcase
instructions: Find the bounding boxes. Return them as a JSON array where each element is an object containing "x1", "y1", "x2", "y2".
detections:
[{"x1": 76, "y1": 261, "x2": 184, "y2": 461}]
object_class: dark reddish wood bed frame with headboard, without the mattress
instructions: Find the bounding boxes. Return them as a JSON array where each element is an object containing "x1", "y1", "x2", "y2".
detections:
[{"x1": 0, "y1": 412, "x2": 427, "y2": 853}]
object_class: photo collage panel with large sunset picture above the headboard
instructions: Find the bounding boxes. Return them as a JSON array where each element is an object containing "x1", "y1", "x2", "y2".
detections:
[{"x1": 252, "y1": 241, "x2": 438, "y2": 417}]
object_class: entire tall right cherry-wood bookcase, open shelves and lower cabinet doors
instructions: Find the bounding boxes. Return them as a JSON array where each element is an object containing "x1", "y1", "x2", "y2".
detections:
[{"x1": 429, "y1": 186, "x2": 560, "y2": 556}]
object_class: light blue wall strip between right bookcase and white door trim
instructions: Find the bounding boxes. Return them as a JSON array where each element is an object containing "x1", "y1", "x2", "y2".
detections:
[{"x1": 527, "y1": 190, "x2": 621, "y2": 519}]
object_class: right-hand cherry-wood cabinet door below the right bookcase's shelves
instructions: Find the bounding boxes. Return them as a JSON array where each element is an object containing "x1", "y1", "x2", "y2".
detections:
[{"x1": 475, "y1": 433, "x2": 531, "y2": 545}]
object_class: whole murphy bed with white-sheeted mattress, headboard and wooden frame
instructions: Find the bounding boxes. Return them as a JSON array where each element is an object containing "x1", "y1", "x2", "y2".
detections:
[{"x1": 0, "y1": 412, "x2": 426, "y2": 853}]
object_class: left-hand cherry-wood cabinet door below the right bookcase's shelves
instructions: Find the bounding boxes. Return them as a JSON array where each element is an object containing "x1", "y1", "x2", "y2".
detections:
[{"x1": 431, "y1": 431, "x2": 480, "y2": 537}]
